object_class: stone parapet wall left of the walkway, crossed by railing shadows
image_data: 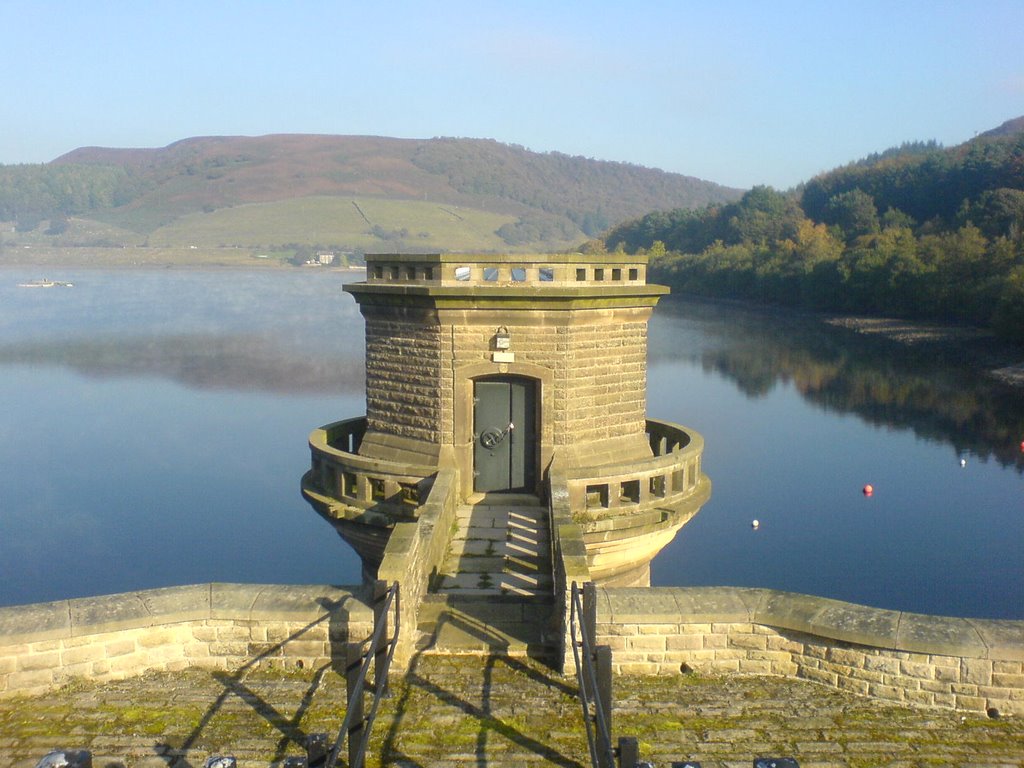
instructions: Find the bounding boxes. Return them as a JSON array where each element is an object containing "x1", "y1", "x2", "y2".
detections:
[{"x1": 0, "y1": 584, "x2": 373, "y2": 697}]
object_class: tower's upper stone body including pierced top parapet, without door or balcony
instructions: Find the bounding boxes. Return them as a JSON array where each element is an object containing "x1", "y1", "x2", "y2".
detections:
[{"x1": 345, "y1": 254, "x2": 666, "y2": 468}]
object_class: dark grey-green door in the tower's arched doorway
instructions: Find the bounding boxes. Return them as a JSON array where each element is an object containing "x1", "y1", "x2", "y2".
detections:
[{"x1": 473, "y1": 376, "x2": 538, "y2": 493}]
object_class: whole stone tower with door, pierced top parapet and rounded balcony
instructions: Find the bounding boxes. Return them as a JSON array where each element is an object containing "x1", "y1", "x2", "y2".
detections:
[{"x1": 303, "y1": 254, "x2": 710, "y2": 584}]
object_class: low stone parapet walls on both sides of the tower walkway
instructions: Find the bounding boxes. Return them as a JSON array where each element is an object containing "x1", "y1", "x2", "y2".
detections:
[{"x1": 0, "y1": 584, "x2": 1024, "y2": 716}]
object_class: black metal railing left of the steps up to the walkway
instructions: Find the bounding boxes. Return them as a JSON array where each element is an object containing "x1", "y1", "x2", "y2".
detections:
[{"x1": 324, "y1": 582, "x2": 401, "y2": 768}]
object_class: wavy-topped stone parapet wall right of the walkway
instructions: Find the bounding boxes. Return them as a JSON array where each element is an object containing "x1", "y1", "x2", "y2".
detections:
[{"x1": 597, "y1": 588, "x2": 1024, "y2": 716}]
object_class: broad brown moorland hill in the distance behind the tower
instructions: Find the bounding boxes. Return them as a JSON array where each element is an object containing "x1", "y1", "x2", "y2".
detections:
[{"x1": 0, "y1": 135, "x2": 740, "y2": 259}]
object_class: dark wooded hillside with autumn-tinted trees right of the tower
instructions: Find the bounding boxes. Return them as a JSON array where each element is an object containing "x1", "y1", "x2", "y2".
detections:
[{"x1": 603, "y1": 120, "x2": 1024, "y2": 341}]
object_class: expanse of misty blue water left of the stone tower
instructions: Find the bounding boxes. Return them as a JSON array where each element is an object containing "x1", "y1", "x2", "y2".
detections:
[{"x1": 0, "y1": 270, "x2": 364, "y2": 604}]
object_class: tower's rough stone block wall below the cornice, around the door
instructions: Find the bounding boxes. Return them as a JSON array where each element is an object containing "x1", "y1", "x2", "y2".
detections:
[{"x1": 366, "y1": 307, "x2": 650, "y2": 468}]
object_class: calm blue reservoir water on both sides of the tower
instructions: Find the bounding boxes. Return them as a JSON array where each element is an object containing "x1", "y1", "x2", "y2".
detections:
[{"x1": 0, "y1": 269, "x2": 1024, "y2": 618}]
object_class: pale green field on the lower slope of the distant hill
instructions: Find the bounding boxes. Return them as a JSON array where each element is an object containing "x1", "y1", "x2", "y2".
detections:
[{"x1": 148, "y1": 197, "x2": 584, "y2": 251}]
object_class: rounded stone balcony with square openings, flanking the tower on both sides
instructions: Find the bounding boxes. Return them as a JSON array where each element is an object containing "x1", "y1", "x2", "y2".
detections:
[{"x1": 302, "y1": 417, "x2": 711, "y2": 586}]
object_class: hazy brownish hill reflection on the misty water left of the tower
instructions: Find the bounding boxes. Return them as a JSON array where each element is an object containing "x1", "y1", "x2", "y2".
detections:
[{"x1": 0, "y1": 334, "x2": 365, "y2": 394}]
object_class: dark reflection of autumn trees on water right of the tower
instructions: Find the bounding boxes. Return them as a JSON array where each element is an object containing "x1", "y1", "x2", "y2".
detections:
[{"x1": 651, "y1": 299, "x2": 1024, "y2": 471}]
